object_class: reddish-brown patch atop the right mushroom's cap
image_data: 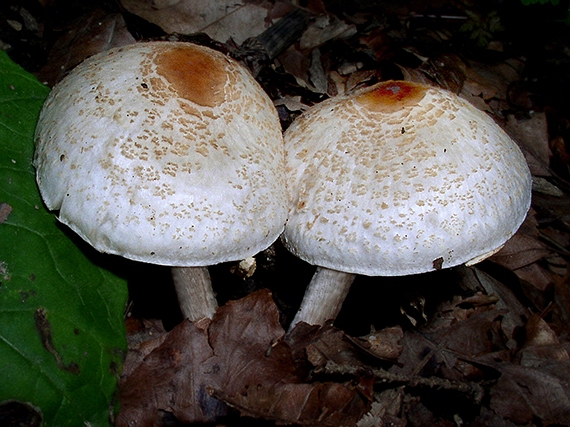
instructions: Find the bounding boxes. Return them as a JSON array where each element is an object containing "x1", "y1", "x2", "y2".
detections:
[{"x1": 356, "y1": 81, "x2": 427, "y2": 113}]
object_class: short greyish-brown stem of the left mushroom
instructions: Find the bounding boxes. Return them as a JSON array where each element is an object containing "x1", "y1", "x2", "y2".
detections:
[{"x1": 171, "y1": 267, "x2": 218, "y2": 322}]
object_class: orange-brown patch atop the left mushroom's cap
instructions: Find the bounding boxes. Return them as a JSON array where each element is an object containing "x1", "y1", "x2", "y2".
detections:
[{"x1": 154, "y1": 46, "x2": 227, "y2": 107}]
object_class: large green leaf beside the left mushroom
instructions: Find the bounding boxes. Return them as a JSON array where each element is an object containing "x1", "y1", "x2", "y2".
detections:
[{"x1": 0, "y1": 51, "x2": 127, "y2": 427}]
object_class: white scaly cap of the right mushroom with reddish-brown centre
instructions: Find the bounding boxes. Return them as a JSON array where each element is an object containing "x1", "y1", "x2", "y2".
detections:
[{"x1": 282, "y1": 81, "x2": 531, "y2": 276}]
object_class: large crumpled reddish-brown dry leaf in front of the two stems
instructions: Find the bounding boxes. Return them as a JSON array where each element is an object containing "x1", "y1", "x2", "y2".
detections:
[{"x1": 117, "y1": 290, "x2": 369, "y2": 427}]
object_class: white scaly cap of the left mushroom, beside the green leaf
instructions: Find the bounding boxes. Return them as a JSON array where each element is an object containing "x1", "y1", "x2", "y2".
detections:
[{"x1": 34, "y1": 42, "x2": 287, "y2": 266}]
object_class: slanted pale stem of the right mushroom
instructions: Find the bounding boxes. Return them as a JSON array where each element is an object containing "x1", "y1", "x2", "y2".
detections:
[{"x1": 289, "y1": 267, "x2": 356, "y2": 330}]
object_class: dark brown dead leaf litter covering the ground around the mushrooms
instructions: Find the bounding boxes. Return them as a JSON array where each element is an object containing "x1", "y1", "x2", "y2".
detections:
[{"x1": 3, "y1": 0, "x2": 570, "y2": 427}]
